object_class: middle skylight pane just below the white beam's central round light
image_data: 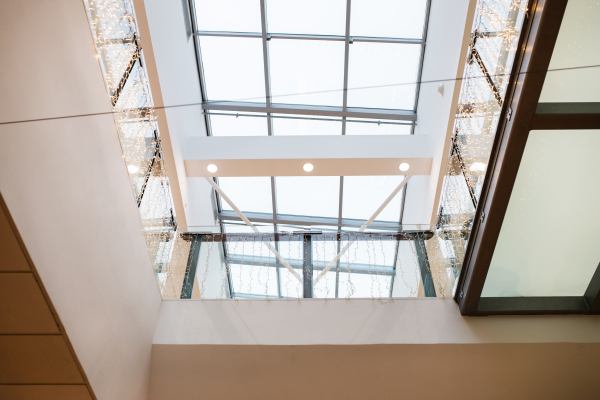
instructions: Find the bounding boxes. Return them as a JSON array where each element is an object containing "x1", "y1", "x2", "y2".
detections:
[{"x1": 275, "y1": 176, "x2": 340, "y2": 218}]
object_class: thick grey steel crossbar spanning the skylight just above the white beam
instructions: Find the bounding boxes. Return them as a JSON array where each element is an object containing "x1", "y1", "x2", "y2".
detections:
[{"x1": 202, "y1": 101, "x2": 417, "y2": 122}]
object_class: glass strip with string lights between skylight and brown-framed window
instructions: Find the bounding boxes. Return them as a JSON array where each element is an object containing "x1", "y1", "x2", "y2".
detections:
[{"x1": 427, "y1": 0, "x2": 527, "y2": 296}]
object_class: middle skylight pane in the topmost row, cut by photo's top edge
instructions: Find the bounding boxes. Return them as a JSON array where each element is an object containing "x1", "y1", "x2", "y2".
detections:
[{"x1": 267, "y1": 0, "x2": 346, "y2": 35}]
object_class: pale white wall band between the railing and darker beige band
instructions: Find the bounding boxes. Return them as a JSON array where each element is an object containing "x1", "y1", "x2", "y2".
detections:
[{"x1": 154, "y1": 297, "x2": 600, "y2": 345}]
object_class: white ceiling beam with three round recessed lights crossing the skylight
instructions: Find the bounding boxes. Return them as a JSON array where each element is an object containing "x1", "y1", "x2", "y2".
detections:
[{"x1": 184, "y1": 135, "x2": 432, "y2": 177}]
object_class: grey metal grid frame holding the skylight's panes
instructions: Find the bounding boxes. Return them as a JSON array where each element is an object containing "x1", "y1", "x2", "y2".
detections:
[{"x1": 185, "y1": 0, "x2": 431, "y2": 298}]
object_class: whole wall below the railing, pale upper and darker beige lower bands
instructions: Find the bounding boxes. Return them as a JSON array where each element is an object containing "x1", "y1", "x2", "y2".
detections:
[{"x1": 150, "y1": 298, "x2": 600, "y2": 400}]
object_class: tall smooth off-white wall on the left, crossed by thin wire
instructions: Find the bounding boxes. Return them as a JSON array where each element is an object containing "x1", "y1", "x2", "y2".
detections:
[{"x1": 0, "y1": 0, "x2": 161, "y2": 400}]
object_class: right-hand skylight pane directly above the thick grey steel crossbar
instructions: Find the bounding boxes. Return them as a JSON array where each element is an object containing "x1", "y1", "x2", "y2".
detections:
[{"x1": 348, "y1": 42, "x2": 421, "y2": 110}]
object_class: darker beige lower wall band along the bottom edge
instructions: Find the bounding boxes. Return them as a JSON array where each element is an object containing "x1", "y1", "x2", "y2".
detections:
[{"x1": 150, "y1": 343, "x2": 600, "y2": 400}]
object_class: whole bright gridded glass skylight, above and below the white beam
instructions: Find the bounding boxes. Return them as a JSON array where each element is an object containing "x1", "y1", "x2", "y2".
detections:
[{"x1": 192, "y1": 0, "x2": 430, "y2": 297}]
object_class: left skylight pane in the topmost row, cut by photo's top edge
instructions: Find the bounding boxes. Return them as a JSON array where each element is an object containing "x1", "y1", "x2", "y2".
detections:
[{"x1": 195, "y1": 0, "x2": 262, "y2": 32}]
